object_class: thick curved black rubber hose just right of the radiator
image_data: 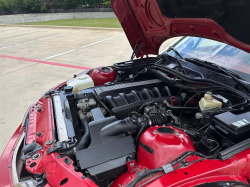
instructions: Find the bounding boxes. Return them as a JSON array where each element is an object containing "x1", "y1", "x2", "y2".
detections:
[{"x1": 76, "y1": 110, "x2": 91, "y2": 151}]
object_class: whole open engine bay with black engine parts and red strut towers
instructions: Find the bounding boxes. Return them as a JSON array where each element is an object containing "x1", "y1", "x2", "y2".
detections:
[{"x1": 20, "y1": 54, "x2": 250, "y2": 187}]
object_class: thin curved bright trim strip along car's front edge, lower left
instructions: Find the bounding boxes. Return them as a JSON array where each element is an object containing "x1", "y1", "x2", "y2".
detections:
[{"x1": 11, "y1": 131, "x2": 25, "y2": 185}]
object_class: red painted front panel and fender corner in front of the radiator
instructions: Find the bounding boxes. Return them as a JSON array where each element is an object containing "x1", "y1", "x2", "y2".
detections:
[{"x1": 26, "y1": 97, "x2": 95, "y2": 187}]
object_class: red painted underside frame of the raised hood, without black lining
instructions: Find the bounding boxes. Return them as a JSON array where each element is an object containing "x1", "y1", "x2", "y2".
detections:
[{"x1": 111, "y1": 0, "x2": 250, "y2": 57}]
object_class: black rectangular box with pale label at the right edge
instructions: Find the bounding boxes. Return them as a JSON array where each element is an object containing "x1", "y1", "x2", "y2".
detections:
[{"x1": 213, "y1": 112, "x2": 250, "y2": 143}]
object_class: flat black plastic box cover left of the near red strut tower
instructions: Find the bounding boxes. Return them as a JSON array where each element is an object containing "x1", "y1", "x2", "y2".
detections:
[{"x1": 76, "y1": 136, "x2": 135, "y2": 180}]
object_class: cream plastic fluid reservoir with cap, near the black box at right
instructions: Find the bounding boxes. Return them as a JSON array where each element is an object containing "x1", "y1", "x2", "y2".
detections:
[{"x1": 199, "y1": 92, "x2": 222, "y2": 112}]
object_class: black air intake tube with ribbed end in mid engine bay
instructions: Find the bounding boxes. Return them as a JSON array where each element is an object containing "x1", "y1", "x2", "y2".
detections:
[{"x1": 101, "y1": 113, "x2": 168, "y2": 136}]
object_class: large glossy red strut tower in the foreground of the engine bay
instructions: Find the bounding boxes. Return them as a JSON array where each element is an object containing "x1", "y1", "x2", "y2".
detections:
[{"x1": 138, "y1": 126, "x2": 195, "y2": 169}]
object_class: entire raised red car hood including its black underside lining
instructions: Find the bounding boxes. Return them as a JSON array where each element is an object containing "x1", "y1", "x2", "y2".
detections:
[{"x1": 111, "y1": 0, "x2": 250, "y2": 57}]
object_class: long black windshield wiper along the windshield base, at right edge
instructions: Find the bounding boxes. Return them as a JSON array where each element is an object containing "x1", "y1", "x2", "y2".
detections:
[{"x1": 185, "y1": 58, "x2": 250, "y2": 91}]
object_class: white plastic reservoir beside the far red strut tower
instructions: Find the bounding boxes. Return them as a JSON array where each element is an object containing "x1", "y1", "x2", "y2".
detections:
[{"x1": 67, "y1": 74, "x2": 94, "y2": 94}]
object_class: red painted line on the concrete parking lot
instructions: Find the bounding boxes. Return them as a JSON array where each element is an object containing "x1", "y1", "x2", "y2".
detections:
[{"x1": 0, "y1": 55, "x2": 92, "y2": 70}]
